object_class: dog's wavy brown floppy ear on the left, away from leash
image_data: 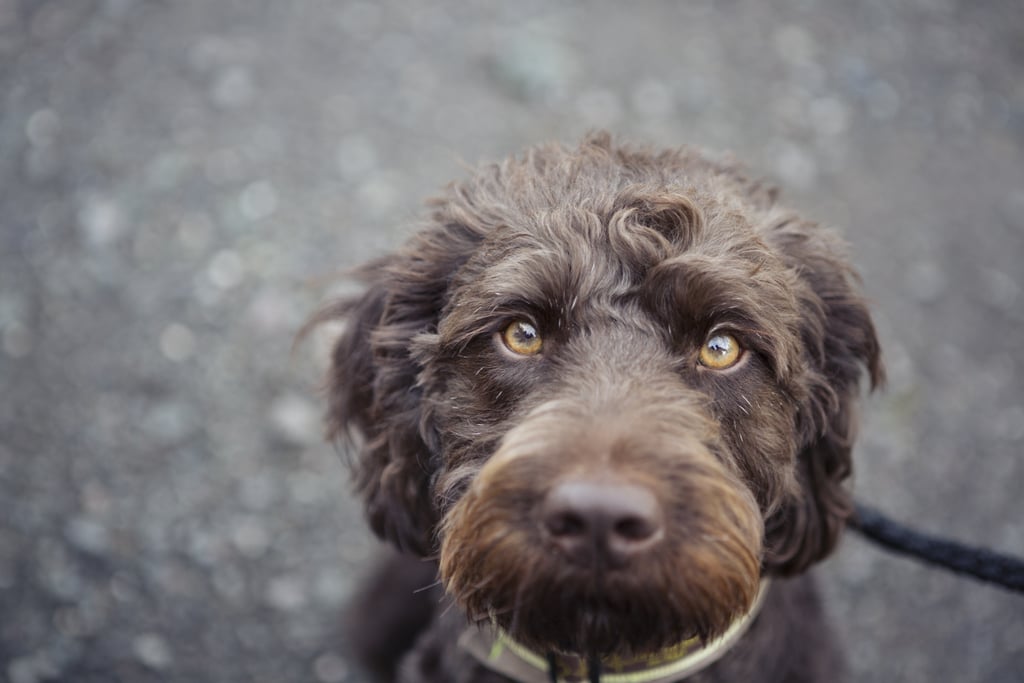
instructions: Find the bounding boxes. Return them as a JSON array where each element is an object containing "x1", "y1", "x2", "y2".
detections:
[{"x1": 310, "y1": 218, "x2": 478, "y2": 555}]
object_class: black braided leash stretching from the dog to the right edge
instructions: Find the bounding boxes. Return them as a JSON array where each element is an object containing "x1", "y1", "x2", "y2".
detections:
[{"x1": 848, "y1": 503, "x2": 1024, "y2": 593}]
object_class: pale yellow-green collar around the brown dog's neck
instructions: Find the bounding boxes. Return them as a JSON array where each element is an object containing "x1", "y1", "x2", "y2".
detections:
[{"x1": 459, "y1": 579, "x2": 770, "y2": 683}]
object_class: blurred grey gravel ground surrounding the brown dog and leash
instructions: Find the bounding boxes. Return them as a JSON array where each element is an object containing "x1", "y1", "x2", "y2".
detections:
[{"x1": 0, "y1": 0, "x2": 1024, "y2": 683}]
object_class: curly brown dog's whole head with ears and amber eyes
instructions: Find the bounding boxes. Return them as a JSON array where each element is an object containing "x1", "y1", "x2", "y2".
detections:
[{"x1": 321, "y1": 135, "x2": 882, "y2": 653}]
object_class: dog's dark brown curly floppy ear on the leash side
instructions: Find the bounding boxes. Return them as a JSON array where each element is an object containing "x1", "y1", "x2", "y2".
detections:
[{"x1": 763, "y1": 217, "x2": 885, "y2": 575}]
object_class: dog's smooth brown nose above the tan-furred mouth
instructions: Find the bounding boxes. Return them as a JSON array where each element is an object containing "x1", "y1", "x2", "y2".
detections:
[{"x1": 542, "y1": 479, "x2": 664, "y2": 568}]
